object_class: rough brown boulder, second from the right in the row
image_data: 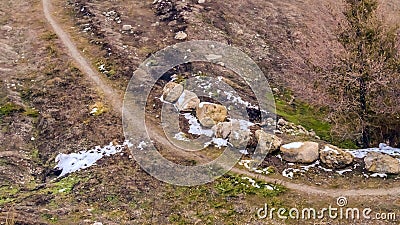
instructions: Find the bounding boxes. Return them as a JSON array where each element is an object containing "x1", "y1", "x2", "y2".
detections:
[{"x1": 319, "y1": 144, "x2": 354, "y2": 169}]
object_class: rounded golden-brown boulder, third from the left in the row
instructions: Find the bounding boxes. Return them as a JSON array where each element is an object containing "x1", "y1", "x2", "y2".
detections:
[{"x1": 196, "y1": 102, "x2": 228, "y2": 127}]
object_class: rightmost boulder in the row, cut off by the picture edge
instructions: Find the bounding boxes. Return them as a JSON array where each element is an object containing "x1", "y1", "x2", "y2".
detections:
[{"x1": 364, "y1": 152, "x2": 400, "y2": 174}]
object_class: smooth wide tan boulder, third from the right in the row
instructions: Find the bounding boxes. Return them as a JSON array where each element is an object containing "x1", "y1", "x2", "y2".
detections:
[{"x1": 280, "y1": 142, "x2": 319, "y2": 163}]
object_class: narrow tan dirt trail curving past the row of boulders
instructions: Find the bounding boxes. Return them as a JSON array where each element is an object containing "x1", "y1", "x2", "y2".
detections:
[{"x1": 42, "y1": 0, "x2": 400, "y2": 197}]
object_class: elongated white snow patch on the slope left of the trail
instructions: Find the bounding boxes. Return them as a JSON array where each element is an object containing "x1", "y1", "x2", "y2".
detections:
[{"x1": 55, "y1": 141, "x2": 132, "y2": 177}]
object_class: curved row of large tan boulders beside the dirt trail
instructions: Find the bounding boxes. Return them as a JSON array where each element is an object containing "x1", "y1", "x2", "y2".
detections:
[{"x1": 162, "y1": 82, "x2": 400, "y2": 174}]
